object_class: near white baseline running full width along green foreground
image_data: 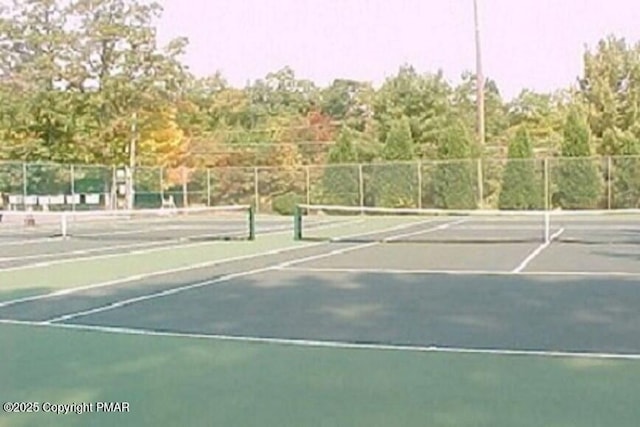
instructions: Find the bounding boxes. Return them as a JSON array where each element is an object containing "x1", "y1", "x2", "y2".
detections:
[{"x1": 0, "y1": 319, "x2": 640, "y2": 360}]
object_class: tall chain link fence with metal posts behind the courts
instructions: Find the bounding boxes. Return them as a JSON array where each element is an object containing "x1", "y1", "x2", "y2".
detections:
[{"x1": 0, "y1": 156, "x2": 640, "y2": 214}]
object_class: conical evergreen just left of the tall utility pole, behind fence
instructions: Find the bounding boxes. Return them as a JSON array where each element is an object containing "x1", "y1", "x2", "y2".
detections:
[{"x1": 431, "y1": 120, "x2": 477, "y2": 209}]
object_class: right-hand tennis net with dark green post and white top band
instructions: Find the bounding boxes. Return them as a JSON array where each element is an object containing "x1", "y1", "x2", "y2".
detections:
[{"x1": 294, "y1": 205, "x2": 640, "y2": 244}]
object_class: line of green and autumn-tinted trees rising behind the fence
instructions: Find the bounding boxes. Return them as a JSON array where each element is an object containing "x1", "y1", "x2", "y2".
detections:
[{"x1": 0, "y1": 0, "x2": 640, "y2": 208}]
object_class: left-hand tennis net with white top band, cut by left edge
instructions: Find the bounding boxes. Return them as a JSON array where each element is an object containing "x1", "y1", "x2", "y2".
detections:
[{"x1": 0, "y1": 205, "x2": 255, "y2": 241}]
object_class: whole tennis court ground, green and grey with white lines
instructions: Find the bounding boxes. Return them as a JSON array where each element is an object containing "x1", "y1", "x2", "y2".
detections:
[{"x1": 0, "y1": 207, "x2": 640, "y2": 426}]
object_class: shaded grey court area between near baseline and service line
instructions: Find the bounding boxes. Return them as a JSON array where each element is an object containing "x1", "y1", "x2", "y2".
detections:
[{"x1": 5, "y1": 271, "x2": 640, "y2": 354}]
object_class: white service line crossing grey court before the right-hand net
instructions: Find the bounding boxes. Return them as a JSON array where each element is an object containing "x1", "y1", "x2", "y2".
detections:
[{"x1": 278, "y1": 267, "x2": 640, "y2": 278}]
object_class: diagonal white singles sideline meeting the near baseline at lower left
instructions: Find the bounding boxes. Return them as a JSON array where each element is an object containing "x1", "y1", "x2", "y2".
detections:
[{"x1": 42, "y1": 220, "x2": 464, "y2": 323}]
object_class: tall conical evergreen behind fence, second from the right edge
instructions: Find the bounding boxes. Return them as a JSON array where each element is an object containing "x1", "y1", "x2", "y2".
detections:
[{"x1": 556, "y1": 109, "x2": 602, "y2": 209}]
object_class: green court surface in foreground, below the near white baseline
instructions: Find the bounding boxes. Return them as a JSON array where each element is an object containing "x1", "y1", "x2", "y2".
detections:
[{"x1": 0, "y1": 325, "x2": 640, "y2": 427}]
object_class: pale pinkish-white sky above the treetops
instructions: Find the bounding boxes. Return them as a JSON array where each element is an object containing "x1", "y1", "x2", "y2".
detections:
[{"x1": 158, "y1": 0, "x2": 640, "y2": 99}]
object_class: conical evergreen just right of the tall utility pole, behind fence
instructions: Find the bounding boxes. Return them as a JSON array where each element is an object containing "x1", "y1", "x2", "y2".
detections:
[{"x1": 498, "y1": 127, "x2": 541, "y2": 210}]
